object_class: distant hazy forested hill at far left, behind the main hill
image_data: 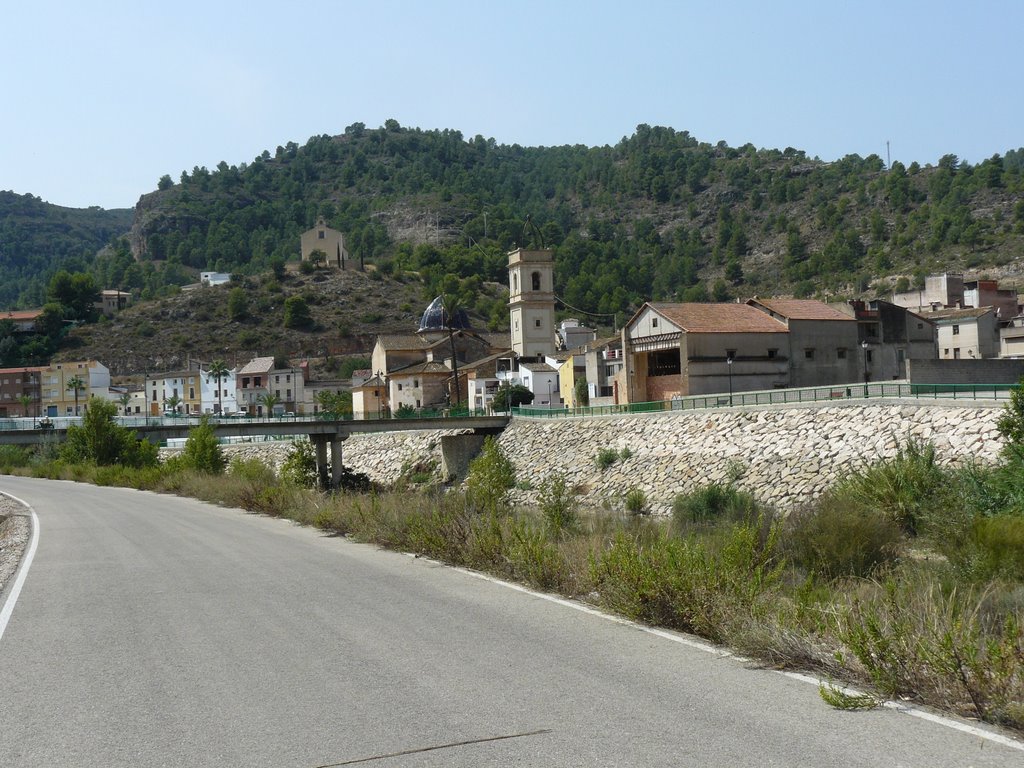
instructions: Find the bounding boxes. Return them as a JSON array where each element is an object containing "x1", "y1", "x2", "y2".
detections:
[{"x1": 0, "y1": 191, "x2": 132, "y2": 309}]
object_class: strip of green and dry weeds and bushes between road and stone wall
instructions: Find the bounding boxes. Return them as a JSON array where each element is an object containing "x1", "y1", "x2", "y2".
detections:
[{"x1": 0, "y1": 401, "x2": 1024, "y2": 733}]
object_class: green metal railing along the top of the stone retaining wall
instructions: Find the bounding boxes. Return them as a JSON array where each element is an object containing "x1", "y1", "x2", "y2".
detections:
[{"x1": 512, "y1": 382, "x2": 1017, "y2": 419}]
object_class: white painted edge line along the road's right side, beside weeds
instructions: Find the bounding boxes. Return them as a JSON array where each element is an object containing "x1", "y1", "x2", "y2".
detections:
[{"x1": 446, "y1": 558, "x2": 1024, "y2": 752}]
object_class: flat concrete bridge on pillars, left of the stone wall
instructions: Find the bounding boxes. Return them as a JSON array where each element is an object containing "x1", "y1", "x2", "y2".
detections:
[{"x1": 0, "y1": 416, "x2": 510, "y2": 487}]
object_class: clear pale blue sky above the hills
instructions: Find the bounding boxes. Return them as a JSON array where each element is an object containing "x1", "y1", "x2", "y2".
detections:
[{"x1": 0, "y1": 0, "x2": 1024, "y2": 208}]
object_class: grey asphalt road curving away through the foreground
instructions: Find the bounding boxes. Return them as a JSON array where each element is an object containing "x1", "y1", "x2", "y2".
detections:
[{"x1": 0, "y1": 477, "x2": 1024, "y2": 768}]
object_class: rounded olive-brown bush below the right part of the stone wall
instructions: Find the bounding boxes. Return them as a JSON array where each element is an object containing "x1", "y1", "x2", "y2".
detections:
[{"x1": 785, "y1": 497, "x2": 902, "y2": 579}]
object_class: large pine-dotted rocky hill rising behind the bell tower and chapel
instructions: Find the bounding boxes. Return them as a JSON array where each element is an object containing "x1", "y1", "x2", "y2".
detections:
[{"x1": 128, "y1": 121, "x2": 1024, "y2": 313}]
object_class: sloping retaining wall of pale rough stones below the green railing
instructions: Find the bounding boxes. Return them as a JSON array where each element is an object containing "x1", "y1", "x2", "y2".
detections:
[{"x1": 163, "y1": 401, "x2": 1002, "y2": 513}]
